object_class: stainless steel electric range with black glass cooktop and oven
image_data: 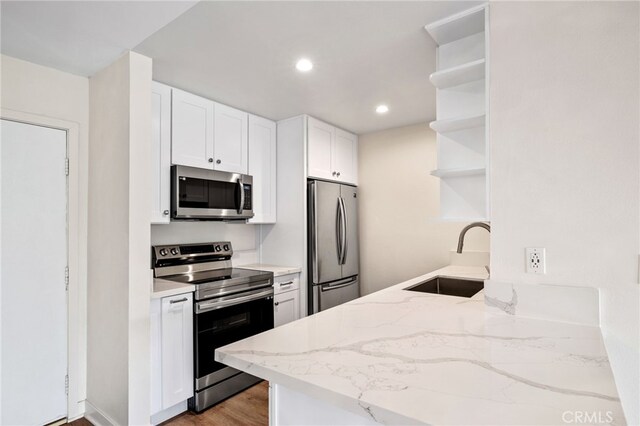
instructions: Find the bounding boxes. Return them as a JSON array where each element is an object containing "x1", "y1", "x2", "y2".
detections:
[{"x1": 152, "y1": 242, "x2": 273, "y2": 413}]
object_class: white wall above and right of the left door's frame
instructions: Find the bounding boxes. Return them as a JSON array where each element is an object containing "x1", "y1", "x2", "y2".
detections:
[{"x1": 0, "y1": 55, "x2": 89, "y2": 418}]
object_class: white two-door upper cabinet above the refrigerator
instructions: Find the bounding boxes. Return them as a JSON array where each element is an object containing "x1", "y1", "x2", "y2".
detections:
[{"x1": 307, "y1": 117, "x2": 358, "y2": 184}]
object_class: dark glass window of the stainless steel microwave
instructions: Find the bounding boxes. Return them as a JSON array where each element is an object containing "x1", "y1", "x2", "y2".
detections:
[{"x1": 178, "y1": 176, "x2": 240, "y2": 210}]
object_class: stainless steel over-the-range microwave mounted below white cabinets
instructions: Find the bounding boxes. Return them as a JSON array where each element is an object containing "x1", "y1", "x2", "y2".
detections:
[{"x1": 171, "y1": 166, "x2": 253, "y2": 220}]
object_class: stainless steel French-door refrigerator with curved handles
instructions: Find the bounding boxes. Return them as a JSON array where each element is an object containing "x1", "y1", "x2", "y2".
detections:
[{"x1": 307, "y1": 180, "x2": 360, "y2": 314}]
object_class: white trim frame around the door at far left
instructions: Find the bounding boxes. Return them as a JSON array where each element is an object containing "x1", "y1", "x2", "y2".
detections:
[{"x1": 0, "y1": 108, "x2": 86, "y2": 419}]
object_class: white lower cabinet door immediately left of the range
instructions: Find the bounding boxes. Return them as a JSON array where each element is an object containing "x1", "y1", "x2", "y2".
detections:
[{"x1": 161, "y1": 293, "x2": 193, "y2": 409}]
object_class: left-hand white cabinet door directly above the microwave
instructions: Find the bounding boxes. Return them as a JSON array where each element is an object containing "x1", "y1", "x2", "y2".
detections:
[{"x1": 171, "y1": 89, "x2": 213, "y2": 169}]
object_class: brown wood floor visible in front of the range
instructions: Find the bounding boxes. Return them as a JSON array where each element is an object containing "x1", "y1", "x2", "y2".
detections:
[{"x1": 70, "y1": 382, "x2": 269, "y2": 426}]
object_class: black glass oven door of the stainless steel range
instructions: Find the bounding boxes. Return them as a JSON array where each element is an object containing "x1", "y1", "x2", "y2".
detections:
[{"x1": 194, "y1": 286, "x2": 273, "y2": 391}]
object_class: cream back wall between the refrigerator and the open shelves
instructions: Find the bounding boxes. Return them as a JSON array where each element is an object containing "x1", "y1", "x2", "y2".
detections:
[{"x1": 358, "y1": 123, "x2": 489, "y2": 294}]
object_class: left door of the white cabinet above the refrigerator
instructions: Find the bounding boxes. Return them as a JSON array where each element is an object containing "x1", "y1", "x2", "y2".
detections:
[{"x1": 307, "y1": 117, "x2": 335, "y2": 179}]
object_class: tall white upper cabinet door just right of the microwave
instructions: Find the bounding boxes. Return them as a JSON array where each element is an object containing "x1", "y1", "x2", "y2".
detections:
[{"x1": 249, "y1": 115, "x2": 276, "y2": 223}]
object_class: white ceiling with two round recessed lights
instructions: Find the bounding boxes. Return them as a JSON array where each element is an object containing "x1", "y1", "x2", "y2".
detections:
[{"x1": 0, "y1": 0, "x2": 480, "y2": 134}]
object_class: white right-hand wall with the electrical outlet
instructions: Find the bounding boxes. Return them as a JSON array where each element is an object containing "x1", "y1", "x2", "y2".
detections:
[{"x1": 490, "y1": 2, "x2": 640, "y2": 424}]
